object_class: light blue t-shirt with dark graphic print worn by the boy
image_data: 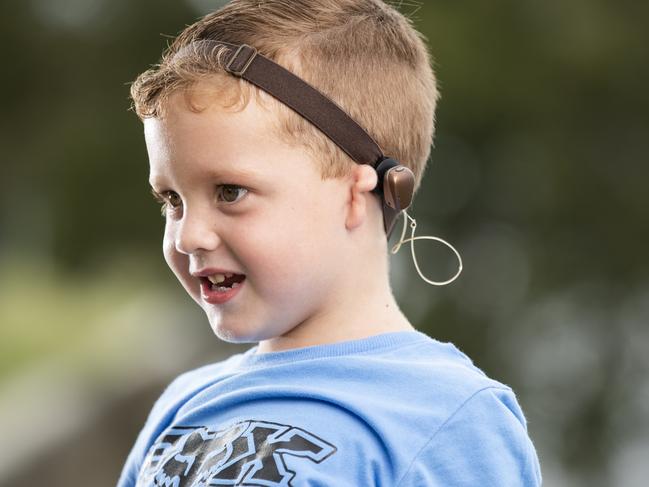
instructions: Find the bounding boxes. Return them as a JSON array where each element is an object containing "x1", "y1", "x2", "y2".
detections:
[{"x1": 118, "y1": 331, "x2": 541, "y2": 487}]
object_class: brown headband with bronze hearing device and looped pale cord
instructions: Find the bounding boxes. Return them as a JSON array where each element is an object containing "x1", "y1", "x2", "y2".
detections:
[{"x1": 175, "y1": 39, "x2": 462, "y2": 286}]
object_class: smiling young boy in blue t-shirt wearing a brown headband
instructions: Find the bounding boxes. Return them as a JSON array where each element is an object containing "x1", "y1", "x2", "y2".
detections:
[{"x1": 118, "y1": 0, "x2": 541, "y2": 487}]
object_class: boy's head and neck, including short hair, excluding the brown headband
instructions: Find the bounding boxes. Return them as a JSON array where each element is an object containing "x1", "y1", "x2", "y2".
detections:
[{"x1": 131, "y1": 0, "x2": 438, "y2": 346}]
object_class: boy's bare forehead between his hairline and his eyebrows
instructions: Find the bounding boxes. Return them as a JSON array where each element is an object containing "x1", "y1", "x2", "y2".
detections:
[{"x1": 144, "y1": 87, "x2": 314, "y2": 183}]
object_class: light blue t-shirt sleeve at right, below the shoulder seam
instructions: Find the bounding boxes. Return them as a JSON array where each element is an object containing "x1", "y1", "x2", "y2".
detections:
[{"x1": 398, "y1": 387, "x2": 542, "y2": 487}]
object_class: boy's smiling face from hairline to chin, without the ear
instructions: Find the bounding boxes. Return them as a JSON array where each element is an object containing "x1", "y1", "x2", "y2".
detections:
[{"x1": 144, "y1": 86, "x2": 360, "y2": 342}]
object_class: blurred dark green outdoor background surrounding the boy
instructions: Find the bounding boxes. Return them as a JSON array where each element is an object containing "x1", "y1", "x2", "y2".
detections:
[{"x1": 0, "y1": 0, "x2": 649, "y2": 487}]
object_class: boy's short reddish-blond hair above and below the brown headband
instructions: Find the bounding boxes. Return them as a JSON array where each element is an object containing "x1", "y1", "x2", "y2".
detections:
[{"x1": 130, "y1": 0, "x2": 439, "y2": 191}]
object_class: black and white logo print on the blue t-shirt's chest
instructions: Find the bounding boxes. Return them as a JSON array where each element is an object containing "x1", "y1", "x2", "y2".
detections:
[{"x1": 137, "y1": 419, "x2": 336, "y2": 487}]
